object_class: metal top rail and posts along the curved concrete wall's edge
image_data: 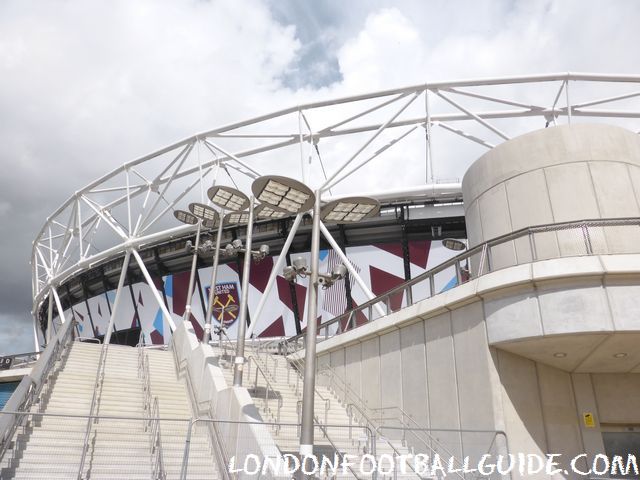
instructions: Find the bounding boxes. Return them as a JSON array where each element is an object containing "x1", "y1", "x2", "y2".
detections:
[{"x1": 281, "y1": 217, "x2": 640, "y2": 351}]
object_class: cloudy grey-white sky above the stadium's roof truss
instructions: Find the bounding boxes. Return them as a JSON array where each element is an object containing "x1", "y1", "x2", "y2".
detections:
[{"x1": 0, "y1": 0, "x2": 640, "y2": 354}]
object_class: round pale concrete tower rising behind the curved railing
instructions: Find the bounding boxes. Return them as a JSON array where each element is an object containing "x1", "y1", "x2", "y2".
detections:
[{"x1": 462, "y1": 124, "x2": 640, "y2": 268}]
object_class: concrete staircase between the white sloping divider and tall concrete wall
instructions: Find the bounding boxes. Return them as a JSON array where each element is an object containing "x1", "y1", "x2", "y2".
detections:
[{"x1": 213, "y1": 346, "x2": 419, "y2": 479}]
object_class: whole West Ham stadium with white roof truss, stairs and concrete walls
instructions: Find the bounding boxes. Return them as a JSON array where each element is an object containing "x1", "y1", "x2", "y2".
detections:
[{"x1": 0, "y1": 73, "x2": 640, "y2": 479}]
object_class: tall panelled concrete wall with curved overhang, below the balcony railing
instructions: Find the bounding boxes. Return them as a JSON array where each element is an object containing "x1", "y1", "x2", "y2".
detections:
[{"x1": 317, "y1": 255, "x2": 640, "y2": 480}]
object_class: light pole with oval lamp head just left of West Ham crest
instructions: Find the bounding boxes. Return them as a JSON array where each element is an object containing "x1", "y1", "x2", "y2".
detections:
[{"x1": 202, "y1": 186, "x2": 249, "y2": 343}]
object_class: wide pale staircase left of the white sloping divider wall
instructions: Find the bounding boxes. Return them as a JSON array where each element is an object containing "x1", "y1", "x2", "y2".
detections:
[{"x1": 0, "y1": 342, "x2": 217, "y2": 480}]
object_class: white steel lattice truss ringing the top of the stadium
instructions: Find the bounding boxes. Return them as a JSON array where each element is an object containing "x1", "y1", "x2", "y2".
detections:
[{"x1": 31, "y1": 73, "x2": 640, "y2": 346}]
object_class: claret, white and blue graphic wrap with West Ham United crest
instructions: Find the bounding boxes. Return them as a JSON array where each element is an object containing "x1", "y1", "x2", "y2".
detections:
[{"x1": 54, "y1": 240, "x2": 456, "y2": 344}]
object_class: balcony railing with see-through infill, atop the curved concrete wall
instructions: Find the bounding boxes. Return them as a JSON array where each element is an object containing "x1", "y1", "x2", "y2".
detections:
[{"x1": 281, "y1": 217, "x2": 640, "y2": 352}]
